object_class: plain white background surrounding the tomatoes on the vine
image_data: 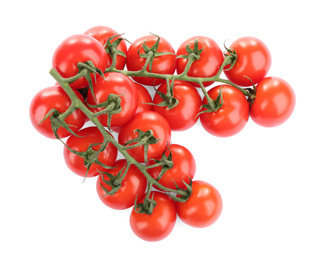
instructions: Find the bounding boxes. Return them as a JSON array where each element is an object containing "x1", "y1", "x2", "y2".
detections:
[{"x1": 0, "y1": 0, "x2": 324, "y2": 260}]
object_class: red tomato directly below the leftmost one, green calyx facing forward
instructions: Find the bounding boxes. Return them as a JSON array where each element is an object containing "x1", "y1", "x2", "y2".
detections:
[{"x1": 63, "y1": 126, "x2": 117, "y2": 177}]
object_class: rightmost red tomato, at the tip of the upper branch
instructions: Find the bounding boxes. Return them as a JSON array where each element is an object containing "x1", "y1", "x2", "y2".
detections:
[{"x1": 251, "y1": 77, "x2": 296, "y2": 127}]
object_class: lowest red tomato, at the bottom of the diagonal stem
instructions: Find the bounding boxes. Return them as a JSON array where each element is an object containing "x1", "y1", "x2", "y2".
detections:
[{"x1": 129, "y1": 192, "x2": 177, "y2": 242}]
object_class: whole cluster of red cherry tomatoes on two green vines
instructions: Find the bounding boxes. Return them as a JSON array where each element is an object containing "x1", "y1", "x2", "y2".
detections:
[{"x1": 30, "y1": 26, "x2": 295, "y2": 241}]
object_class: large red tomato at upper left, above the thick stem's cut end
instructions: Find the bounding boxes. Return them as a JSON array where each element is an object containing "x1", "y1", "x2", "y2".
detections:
[{"x1": 52, "y1": 34, "x2": 108, "y2": 89}]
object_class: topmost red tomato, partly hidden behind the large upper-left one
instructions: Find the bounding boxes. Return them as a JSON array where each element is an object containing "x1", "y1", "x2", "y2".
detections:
[{"x1": 85, "y1": 26, "x2": 127, "y2": 70}]
